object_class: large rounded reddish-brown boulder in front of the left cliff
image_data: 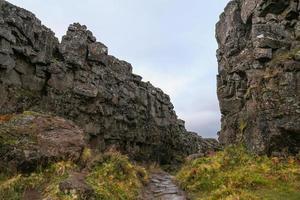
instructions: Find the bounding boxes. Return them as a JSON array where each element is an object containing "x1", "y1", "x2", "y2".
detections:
[{"x1": 0, "y1": 112, "x2": 87, "y2": 172}]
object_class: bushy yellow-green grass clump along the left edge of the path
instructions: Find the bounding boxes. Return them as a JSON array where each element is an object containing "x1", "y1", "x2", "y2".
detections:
[{"x1": 87, "y1": 152, "x2": 148, "y2": 200}]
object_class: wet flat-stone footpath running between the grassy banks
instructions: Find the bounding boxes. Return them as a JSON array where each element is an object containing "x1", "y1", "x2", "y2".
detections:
[{"x1": 140, "y1": 172, "x2": 187, "y2": 200}]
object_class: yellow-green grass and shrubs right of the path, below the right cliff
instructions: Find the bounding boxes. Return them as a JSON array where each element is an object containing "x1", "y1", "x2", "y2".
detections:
[{"x1": 176, "y1": 146, "x2": 300, "y2": 200}]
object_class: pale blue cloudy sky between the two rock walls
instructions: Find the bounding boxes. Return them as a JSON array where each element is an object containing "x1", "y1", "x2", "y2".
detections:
[{"x1": 8, "y1": 0, "x2": 229, "y2": 137}]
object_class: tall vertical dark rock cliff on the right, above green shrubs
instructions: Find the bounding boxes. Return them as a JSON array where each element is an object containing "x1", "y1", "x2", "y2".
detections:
[{"x1": 216, "y1": 0, "x2": 300, "y2": 153}]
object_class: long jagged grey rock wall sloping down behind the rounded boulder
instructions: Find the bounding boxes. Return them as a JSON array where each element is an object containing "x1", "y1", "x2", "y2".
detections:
[{"x1": 0, "y1": 1, "x2": 218, "y2": 163}]
